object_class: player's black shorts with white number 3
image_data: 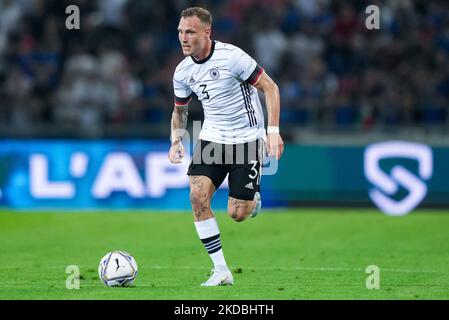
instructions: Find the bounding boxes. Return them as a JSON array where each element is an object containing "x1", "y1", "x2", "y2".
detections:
[{"x1": 187, "y1": 139, "x2": 263, "y2": 200}]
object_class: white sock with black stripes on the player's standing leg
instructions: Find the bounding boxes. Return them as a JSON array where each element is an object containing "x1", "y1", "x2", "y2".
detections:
[{"x1": 194, "y1": 218, "x2": 228, "y2": 270}]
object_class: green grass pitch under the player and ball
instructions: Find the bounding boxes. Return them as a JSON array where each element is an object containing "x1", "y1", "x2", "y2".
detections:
[{"x1": 0, "y1": 209, "x2": 449, "y2": 300}]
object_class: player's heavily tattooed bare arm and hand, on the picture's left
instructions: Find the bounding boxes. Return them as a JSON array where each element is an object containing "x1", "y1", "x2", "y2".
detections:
[{"x1": 168, "y1": 102, "x2": 189, "y2": 163}]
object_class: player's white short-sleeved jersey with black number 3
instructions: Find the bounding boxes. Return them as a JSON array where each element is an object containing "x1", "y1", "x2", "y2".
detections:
[{"x1": 173, "y1": 41, "x2": 265, "y2": 144}]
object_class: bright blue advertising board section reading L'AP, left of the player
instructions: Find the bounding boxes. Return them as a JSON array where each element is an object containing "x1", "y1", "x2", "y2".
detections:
[{"x1": 0, "y1": 140, "x2": 217, "y2": 209}]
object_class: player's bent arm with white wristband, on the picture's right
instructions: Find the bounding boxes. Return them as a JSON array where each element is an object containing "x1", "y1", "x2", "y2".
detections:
[{"x1": 253, "y1": 71, "x2": 284, "y2": 160}]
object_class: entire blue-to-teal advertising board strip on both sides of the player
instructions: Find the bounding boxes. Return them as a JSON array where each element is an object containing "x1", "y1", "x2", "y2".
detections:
[{"x1": 0, "y1": 140, "x2": 449, "y2": 215}]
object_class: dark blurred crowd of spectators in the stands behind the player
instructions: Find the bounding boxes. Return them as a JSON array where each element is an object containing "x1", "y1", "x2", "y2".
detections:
[{"x1": 0, "y1": 0, "x2": 449, "y2": 137}]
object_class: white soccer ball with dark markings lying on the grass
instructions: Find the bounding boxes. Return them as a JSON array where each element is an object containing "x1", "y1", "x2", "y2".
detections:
[{"x1": 98, "y1": 251, "x2": 137, "y2": 287}]
